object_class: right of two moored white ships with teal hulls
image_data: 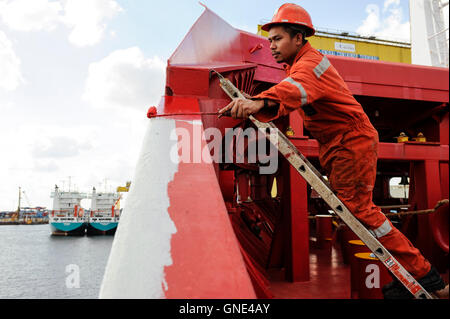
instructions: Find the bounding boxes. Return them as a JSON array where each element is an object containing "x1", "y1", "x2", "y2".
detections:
[{"x1": 86, "y1": 187, "x2": 121, "y2": 235}]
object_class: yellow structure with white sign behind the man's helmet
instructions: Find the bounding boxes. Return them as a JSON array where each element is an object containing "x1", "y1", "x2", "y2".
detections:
[{"x1": 258, "y1": 25, "x2": 411, "y2": 64}]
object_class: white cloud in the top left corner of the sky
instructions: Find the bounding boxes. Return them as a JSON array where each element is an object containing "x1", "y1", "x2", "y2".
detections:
[{"x1": 0, "y1": 0, "x2": 62, "y2": 31}]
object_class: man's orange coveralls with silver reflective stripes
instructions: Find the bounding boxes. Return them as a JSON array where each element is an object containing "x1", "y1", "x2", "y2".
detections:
[{"x1": 254, "y1": 42, "x2": 431, "y2": 279}]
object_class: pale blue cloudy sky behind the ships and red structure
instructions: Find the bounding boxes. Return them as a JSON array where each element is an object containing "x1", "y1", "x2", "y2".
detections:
[{"x1": 0, "y1": 0, "x2": 410, "y2": 211}]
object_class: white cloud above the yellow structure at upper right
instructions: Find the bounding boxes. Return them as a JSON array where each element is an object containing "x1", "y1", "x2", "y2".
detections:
[{"x1": 356, "y1": 0, "x2": 411, "y2": 41}]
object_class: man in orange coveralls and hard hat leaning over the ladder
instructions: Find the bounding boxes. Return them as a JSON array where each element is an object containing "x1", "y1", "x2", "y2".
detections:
[{"x1": 219, "y1": 3, "x2": 445, "y2": 299}]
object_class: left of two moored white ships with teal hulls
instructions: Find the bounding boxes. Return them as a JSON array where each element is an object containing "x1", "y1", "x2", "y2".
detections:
[{"x1": 49, "y1": 185, "x2": 87, "y2": 236}]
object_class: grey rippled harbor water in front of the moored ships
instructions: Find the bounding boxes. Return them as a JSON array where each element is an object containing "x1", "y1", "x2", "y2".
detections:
[{"x1": 0, "y1": 225, "x2": 114, "y2": 299}]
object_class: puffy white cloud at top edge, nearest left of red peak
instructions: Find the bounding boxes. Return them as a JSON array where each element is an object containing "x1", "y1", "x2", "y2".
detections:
[{"x1": 63, "y1": 0, "x2": 122, "y2": 47}]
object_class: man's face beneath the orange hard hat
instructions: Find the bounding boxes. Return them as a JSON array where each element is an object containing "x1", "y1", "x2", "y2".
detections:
[{"x1": 268, "y1": 26, "x2": 303, "y2": 65}]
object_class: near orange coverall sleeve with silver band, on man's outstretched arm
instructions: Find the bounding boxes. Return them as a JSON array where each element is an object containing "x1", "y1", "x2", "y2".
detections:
[{"x1": 253, "y1": 67, "x2": 324, "y2": 122}]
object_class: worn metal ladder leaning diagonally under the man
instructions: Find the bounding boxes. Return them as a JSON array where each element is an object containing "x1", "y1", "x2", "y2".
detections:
[{"x1": 213, "y1": 70, "x2": 435, "y2": 299}]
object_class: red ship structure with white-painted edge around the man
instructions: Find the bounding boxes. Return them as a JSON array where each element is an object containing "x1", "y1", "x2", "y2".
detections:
[{"x1": 100, "y1": 5, "x2": 449, "y2": 299}]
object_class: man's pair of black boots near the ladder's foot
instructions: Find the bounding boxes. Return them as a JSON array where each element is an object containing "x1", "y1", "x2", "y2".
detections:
[{"x1": 381, "y1": 266, "x2": 445, "y2": 299}]
